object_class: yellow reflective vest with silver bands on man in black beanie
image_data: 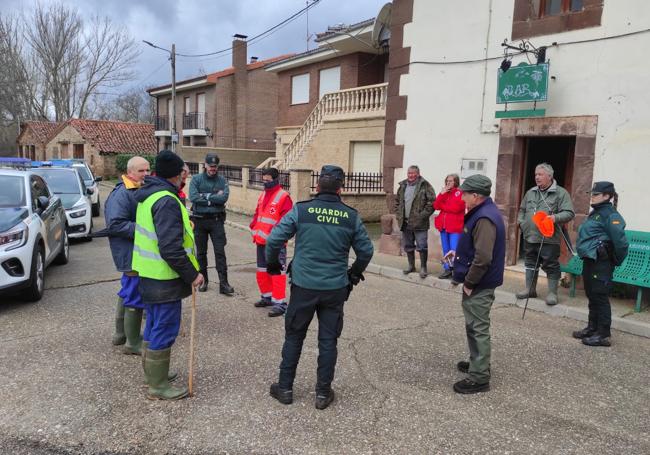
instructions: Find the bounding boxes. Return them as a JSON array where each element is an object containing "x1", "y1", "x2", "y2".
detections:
[{"x1": 131, "y1": 191, "x2": 199, "y2": 280}]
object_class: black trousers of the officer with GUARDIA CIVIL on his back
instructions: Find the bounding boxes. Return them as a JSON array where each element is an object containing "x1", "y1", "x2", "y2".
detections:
[{"x1": 279, "y1": 284, "x2": 348, "y2": 393}]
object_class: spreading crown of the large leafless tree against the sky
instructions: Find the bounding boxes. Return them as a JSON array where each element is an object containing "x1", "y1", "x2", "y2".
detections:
[{"x1": 0, "y1": 3, "x2": 139, "y2": 121}]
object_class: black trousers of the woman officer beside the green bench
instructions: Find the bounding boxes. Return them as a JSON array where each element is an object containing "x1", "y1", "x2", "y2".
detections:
[{"x1": 582, "y1": 259, "x2": 614, "y2": 337}]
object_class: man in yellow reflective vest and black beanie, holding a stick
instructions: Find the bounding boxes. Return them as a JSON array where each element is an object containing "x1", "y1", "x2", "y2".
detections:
[{"x1": 132, "y1": 150, "x2": 203, "y2": 400}]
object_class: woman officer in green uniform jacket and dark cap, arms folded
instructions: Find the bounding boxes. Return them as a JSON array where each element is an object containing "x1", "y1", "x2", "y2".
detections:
[{"x1": 573, "y1": 182, "x2": 628, "y2": 346}]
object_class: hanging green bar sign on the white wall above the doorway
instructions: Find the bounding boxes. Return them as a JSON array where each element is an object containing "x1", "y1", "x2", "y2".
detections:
[{"x1": 497, "y1": 63, "x2": 548, "y2": 104}]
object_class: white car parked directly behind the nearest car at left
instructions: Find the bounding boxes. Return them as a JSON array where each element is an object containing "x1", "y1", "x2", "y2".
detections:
[{"x1": 32, "y1": 166, "x2": 93, "y2": 241}]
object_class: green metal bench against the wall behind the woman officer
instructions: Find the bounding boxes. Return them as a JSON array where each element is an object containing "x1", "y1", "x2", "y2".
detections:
[{"x1": 560, "y1": 231, "x2": 650, "y2": 313}]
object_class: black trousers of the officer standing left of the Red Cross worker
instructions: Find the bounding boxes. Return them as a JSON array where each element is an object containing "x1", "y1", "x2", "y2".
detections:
[{"x1": 192, "y1": 213, "x2": 228, "y2": 282}]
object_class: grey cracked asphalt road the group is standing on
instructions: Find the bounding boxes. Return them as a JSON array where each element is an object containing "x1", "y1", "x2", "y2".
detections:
[{"x1": 0, "y1": 187, "x2": 650, "y2": 454}]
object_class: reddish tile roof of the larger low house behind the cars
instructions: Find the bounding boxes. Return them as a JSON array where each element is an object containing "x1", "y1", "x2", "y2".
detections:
[{"x1": 62, "y1": 119, "x2": 157, "y2": 155}]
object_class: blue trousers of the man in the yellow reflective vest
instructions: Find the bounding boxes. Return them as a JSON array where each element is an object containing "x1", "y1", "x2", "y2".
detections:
[{"x1": 142, "y1": 300, "x2": 181, "y2": 351}]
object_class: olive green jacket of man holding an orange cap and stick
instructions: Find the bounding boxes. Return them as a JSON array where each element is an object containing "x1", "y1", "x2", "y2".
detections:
[{"x1": 517, "y1": 180, "x2": 576, "y2": 245}]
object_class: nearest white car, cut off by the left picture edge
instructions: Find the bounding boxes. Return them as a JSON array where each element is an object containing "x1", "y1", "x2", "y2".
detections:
[{"x1": 0, "y1": 165, "x2": 70, "y2": 301}]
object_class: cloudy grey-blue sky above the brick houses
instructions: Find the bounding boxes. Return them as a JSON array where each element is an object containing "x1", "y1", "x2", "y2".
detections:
[{"x1": 0, "y1": 0, "x2": 388, "y2": 91}]
